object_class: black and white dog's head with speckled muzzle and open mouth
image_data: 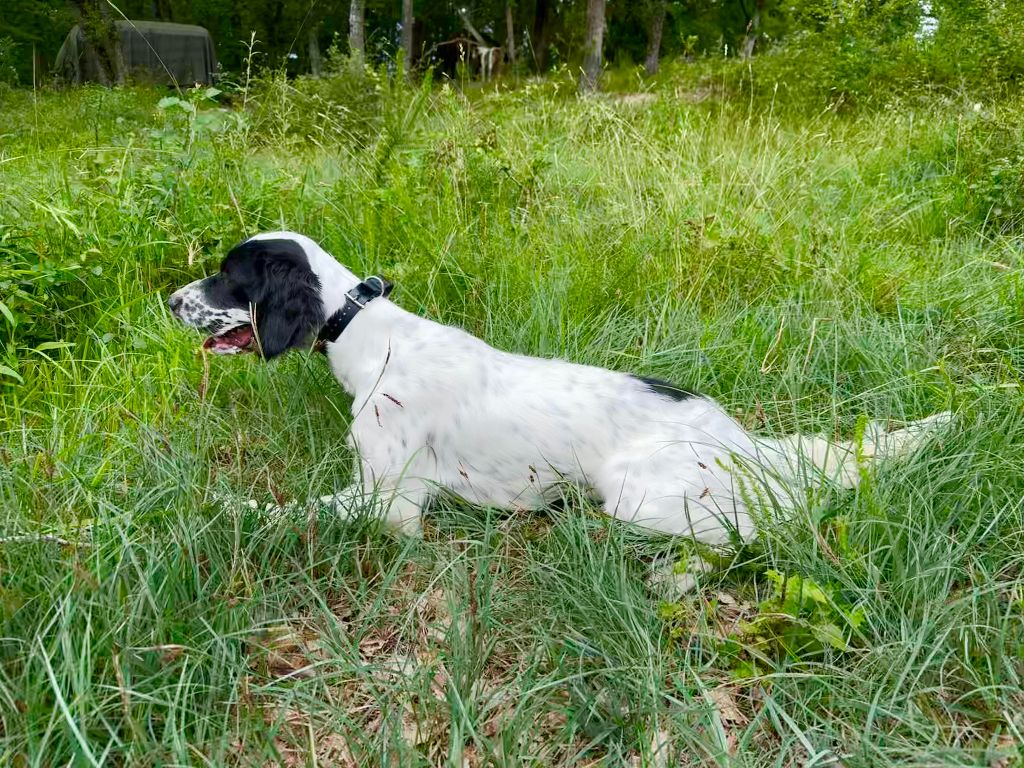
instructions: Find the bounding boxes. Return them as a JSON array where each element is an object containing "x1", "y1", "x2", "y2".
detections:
[{"x1": 168, "y1": 232, "x2": 329, "y2": 359}]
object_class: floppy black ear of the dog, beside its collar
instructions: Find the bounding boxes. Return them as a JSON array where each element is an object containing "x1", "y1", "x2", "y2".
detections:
[{"x1": 253, "y1": 255, "x2": 324, "y2": 359}]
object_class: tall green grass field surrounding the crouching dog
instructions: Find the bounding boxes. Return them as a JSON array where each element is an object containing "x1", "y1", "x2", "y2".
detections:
[{"x1": 0, "y1": 69, "x2": 1024, "y2": 768}]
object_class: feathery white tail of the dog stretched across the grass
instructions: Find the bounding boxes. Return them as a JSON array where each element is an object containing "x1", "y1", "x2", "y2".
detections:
[{"x1": 766, "y1": 411, "x2": 952, "y2": 488}]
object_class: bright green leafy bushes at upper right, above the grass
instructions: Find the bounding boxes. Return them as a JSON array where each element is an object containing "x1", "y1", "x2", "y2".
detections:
[{"x1": 655, "y1": 0, "x2": 1024, "y2": 113}]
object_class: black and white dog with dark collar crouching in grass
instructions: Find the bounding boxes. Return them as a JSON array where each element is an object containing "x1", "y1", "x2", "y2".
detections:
[{"x1": 169, "y1": 231, "x2": 948, "y2": 545}]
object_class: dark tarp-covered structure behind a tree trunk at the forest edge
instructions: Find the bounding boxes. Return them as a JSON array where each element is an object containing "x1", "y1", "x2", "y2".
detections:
[{"x1": 54, "y1": 22, "x2": 217, "y2": 85}]
